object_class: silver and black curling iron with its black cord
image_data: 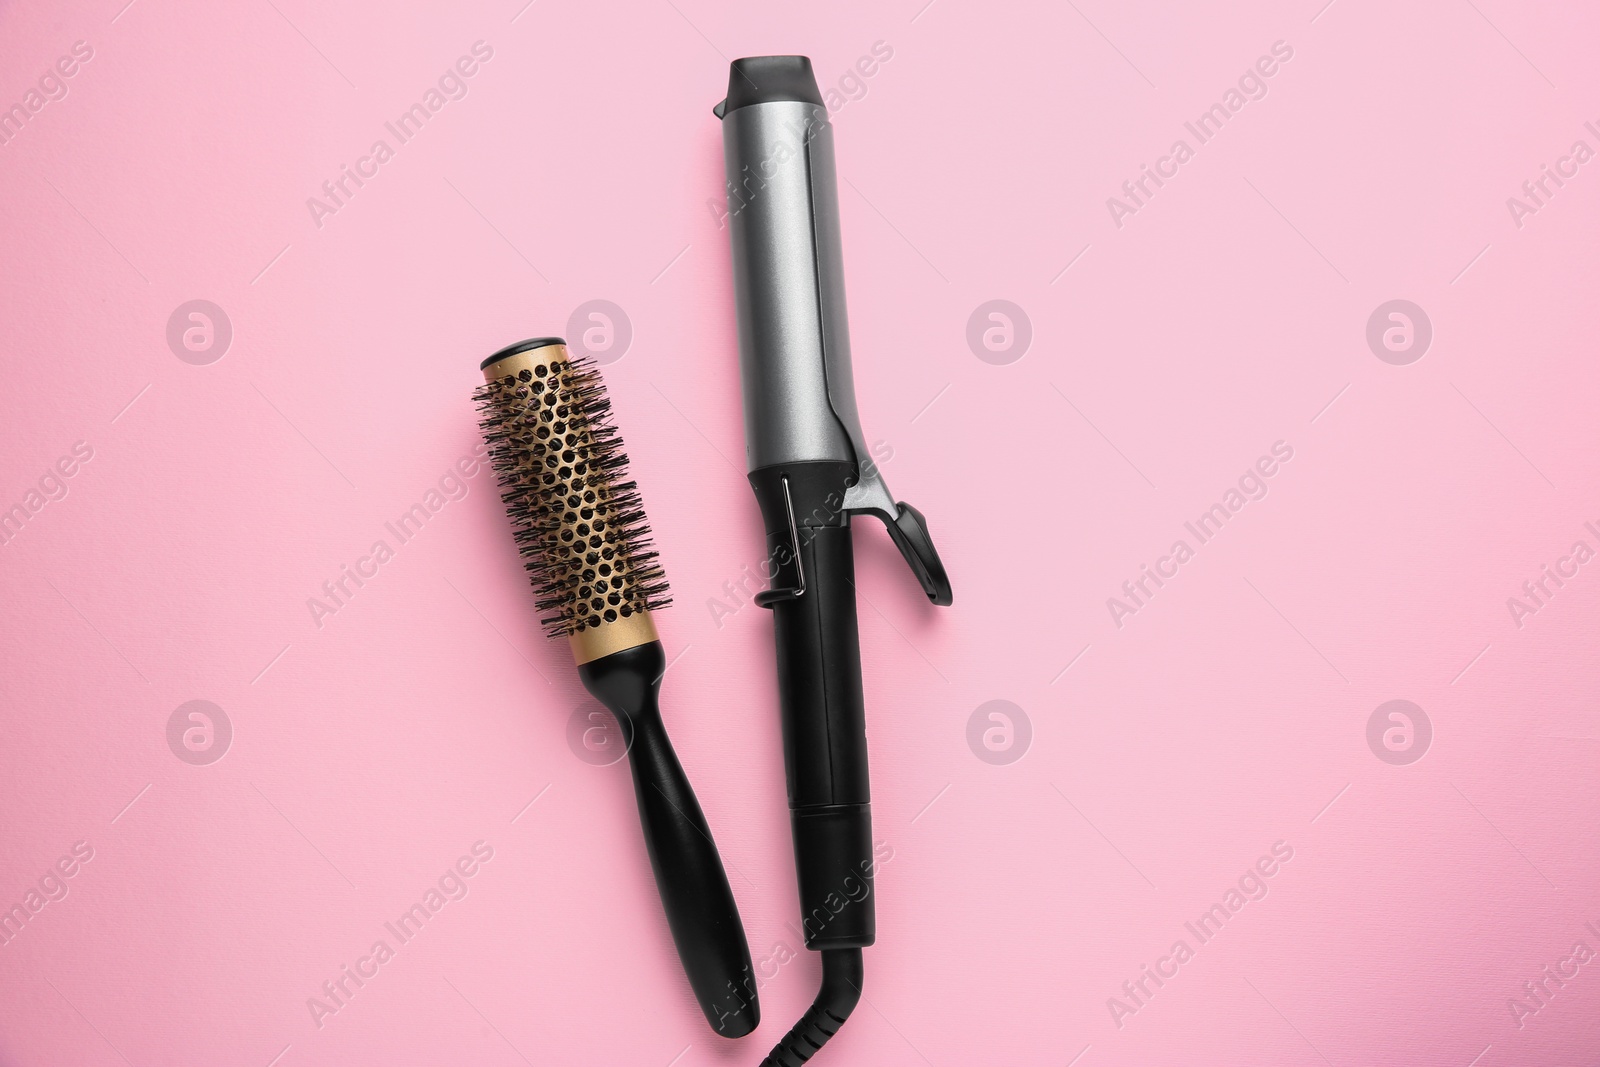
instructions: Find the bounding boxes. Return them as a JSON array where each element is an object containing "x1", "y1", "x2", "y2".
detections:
[{"x1": 714, "y1": 56, "x2": 950, "y2": 1067}]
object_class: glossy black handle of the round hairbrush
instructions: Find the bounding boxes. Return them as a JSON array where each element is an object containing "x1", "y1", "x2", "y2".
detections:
[{"x1": 578, "y1": 641, "x2": 762, "y2": 1038}]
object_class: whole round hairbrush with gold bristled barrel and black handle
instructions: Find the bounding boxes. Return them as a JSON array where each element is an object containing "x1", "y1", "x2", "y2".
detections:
[{"x1": 475, "y1": 338, "x2": 760, "y2": 1038}]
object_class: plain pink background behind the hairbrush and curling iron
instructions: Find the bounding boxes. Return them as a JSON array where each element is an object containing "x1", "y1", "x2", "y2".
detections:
[{"x1": 0, "y1": 0, "x2": 1600, "y2": 1067}]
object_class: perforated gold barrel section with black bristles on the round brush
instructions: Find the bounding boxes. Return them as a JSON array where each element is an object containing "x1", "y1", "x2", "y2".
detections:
[{"x1": 474, "y1": 354, "x2": 672, "y2": 637}]
